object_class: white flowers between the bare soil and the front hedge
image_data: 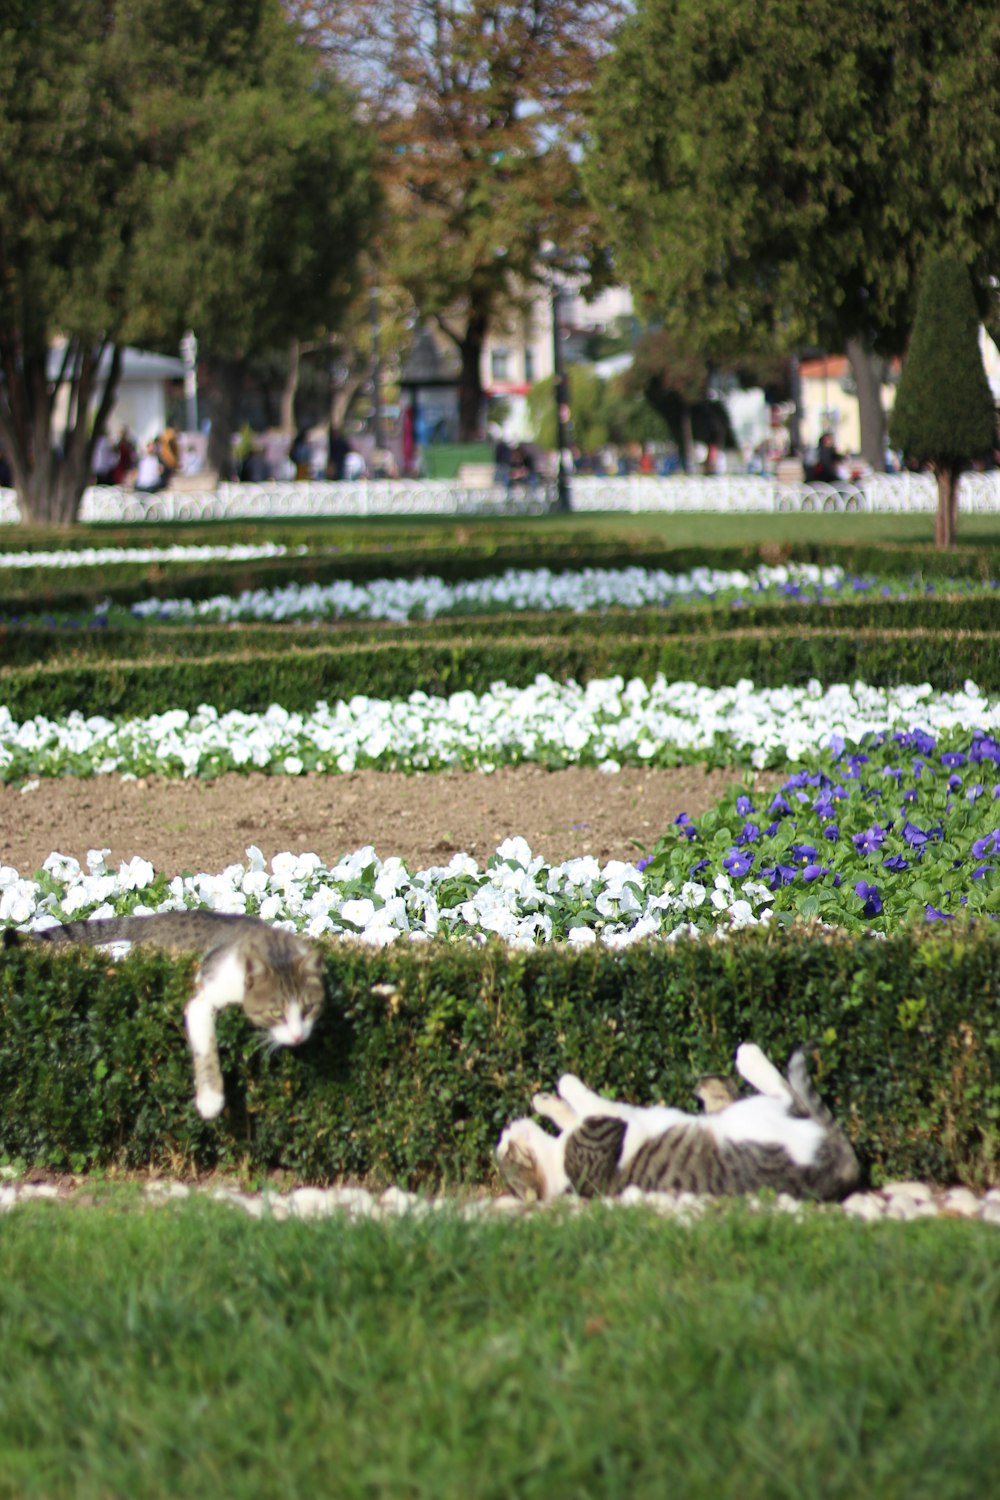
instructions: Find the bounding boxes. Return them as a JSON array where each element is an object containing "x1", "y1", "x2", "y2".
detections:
[{"x1": 0, "y1": 839, "x2": 771, "y2": 947}]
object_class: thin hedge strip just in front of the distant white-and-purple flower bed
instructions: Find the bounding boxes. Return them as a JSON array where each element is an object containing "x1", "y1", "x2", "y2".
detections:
[{"x1": 0, "y1": 596, "x2": 1000, "y2": 666}]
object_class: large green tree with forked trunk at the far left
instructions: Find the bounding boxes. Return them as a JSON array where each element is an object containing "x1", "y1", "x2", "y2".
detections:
[{"x1": 0, "y1": 0, "x2": 372, "y2": 524}]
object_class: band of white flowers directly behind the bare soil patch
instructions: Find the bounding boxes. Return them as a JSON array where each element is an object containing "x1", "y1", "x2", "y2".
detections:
[{"x1": 0, "y1": 675, "x2": 1000, "y2": 782}]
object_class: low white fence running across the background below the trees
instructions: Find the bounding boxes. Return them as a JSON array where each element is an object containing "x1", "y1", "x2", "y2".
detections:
[{"x1": 0, "y1": 470, "x2": 1000, "y2": 524}]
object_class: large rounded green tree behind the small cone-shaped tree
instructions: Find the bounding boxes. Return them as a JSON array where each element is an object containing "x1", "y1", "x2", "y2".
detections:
[{"x1": 585, "y1": 0, "x2": 1000, "y2": 467}]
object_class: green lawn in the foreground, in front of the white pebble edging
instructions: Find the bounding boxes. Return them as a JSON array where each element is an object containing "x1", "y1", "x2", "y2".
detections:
[{"x1": 0, "y1": 1200, "x2": 1000, "y2": 1500}]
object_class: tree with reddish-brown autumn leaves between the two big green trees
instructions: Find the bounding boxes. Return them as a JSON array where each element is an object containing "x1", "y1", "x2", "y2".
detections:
[{"x1": 288, "y1": 0, "x2": 622, "y2": 438}]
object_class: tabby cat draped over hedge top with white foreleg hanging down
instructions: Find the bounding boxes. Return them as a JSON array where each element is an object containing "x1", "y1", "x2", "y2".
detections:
[{"x1": 3, "y1": 911, "x2": 324, "y2": 1119}]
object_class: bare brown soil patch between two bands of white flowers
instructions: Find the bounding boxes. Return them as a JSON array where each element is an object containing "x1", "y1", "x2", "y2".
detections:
[{"x1": 0, "y1": 767, "x2": 775, "y2": 876}]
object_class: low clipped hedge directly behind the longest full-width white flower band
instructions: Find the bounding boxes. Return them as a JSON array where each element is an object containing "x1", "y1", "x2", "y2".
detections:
[{"x1": 0, "y1": 626, "x2": 1000, "y2": 720}]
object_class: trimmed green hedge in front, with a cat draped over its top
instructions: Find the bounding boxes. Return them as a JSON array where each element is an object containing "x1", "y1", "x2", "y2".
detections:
[{"x1": 0, "y1": 929, "x2": 1000, "y2": 1188}]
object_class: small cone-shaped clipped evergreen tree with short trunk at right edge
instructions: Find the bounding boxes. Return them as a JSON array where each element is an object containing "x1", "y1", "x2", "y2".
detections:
[{"x1": 889, "y1": 255, "x2": 996, "y2": 548}]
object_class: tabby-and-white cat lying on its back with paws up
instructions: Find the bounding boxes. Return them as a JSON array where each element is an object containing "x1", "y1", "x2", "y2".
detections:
[{"x1": 496, "y1": 1043, "x2": 858, "y2": 1203}]
